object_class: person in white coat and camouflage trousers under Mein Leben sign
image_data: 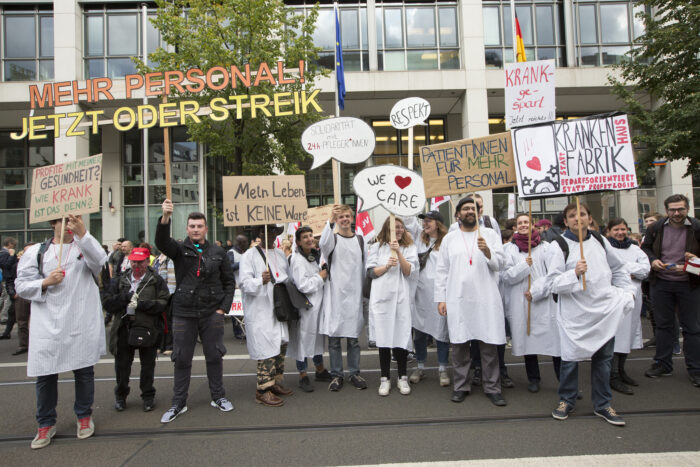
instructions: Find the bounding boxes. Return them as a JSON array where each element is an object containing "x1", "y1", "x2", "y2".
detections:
[{"x1": 239, "y1": 224, "x2": 292, "y2": 407}]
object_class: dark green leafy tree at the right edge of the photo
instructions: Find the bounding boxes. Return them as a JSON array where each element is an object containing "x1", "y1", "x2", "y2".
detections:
[{"x1": 609, "y1": 0, "x2": 700, "y2": 175}]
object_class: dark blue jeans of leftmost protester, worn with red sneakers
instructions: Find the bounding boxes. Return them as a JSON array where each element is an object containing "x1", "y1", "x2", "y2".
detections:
[{"x1": 36, "y1": 366, "x2": 95, "y2": 428}]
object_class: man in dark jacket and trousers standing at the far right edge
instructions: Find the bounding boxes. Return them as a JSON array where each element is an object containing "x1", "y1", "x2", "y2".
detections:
[{"x1": 642, "y1": 195, "x2": 700, "y2": 387}]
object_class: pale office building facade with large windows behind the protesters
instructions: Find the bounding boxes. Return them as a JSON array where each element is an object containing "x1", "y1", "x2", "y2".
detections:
[{"x1": 0, "y1": 0, "x2": 700, "y2": 249}]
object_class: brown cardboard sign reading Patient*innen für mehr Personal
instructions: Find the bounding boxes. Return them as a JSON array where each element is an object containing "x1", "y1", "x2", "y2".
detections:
[{"x1": 420, "y1": 133, "x2": 516, "y2": 197}]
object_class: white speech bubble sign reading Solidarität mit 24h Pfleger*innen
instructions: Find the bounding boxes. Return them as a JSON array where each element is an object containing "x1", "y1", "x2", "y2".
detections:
[{"x1": 301, "y1": 117, "x2": 375, "y2": 170}]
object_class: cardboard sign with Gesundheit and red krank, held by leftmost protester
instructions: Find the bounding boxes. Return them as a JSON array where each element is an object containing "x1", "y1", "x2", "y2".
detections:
[{"x1": 29, "y1": 154, "x2": 102, "y2": 224}]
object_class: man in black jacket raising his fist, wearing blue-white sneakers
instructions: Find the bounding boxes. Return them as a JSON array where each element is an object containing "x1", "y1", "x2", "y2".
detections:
[{"x1": 156, "y1": 199, "x2": 235, "y2": 423}]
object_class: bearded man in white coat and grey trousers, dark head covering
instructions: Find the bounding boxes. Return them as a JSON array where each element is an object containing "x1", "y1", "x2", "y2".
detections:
[{"x1": 435, "y1": 197, "x2": 506, "y2": 406}]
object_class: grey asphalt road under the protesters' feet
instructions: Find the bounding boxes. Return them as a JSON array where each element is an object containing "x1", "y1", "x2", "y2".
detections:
[{"x1": 0, "y1": 316, "x2": 700, "y2": 466}]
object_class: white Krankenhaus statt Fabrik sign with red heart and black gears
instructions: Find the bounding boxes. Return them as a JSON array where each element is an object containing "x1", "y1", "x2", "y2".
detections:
[{"x1": 513, "y1": 114, "x2": 637, "y2": 198}]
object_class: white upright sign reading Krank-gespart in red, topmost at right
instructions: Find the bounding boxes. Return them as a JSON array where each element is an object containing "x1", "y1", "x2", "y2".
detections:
[{"x1": 504, "y1": 60, "x2": 556, "y2": 128}]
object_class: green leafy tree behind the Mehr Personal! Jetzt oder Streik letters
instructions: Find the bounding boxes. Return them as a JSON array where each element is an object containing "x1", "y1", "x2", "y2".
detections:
[{"x1": 142, "y1": 0, "x2": 325, "y2": 175}]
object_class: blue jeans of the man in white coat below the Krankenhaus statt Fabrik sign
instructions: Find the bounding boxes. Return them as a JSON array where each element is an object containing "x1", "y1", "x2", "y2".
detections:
[{"x1": 559, "y1": 337, "x2": 615, "y2": 410}]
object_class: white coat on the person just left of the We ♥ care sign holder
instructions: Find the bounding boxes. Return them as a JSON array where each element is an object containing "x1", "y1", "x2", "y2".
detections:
[{"x1": 319, "y1": 223, "x2": 367, "y2": 338}]
